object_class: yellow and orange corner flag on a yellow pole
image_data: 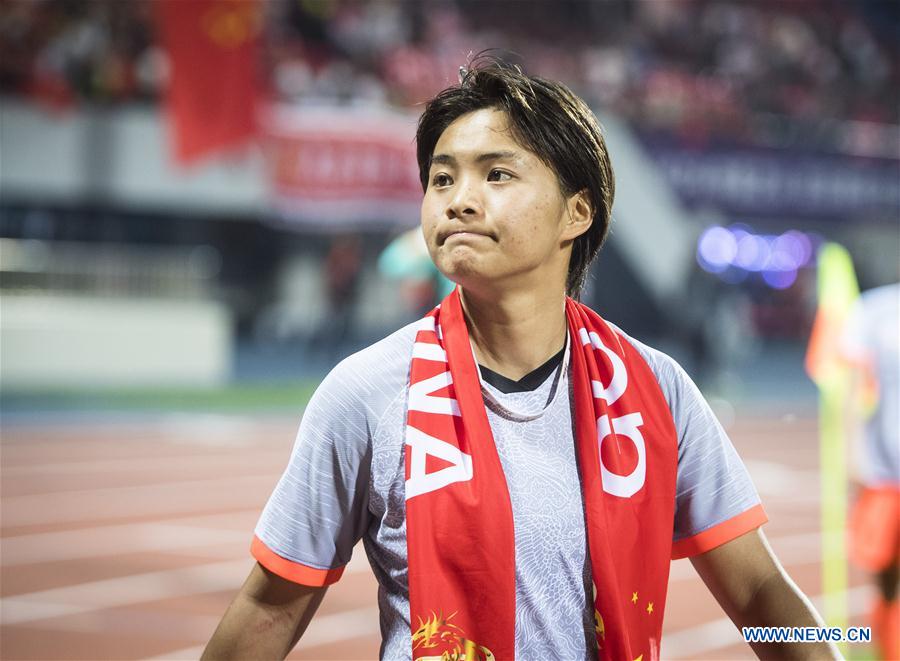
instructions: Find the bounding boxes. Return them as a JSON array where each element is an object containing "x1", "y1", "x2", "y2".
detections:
[{"x1": 806, "y1": 243, "x2": 859, "y2": 644}]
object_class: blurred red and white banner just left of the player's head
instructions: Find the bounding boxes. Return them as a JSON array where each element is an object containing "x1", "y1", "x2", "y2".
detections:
[{"x1": 263, "y1": 106, "x2": 422, "y2": 230}]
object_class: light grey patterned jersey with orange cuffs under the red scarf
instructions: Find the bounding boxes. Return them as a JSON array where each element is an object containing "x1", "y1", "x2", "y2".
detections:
[{"x1": 255, "y1": 324, "x2": 765, "y2": 659}]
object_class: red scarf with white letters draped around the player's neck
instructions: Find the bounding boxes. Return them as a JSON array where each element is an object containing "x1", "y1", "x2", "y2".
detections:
[{"x1": 406, "y1": 288, "x2": 678, "y2": 661}]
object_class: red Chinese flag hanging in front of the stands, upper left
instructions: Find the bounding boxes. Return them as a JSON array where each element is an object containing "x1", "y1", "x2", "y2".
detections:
[{"x1": 156, "y1": 0, "x2": 262, "y2": 164}]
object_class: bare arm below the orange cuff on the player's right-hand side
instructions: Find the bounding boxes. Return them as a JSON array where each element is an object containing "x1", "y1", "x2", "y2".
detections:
[{"x1": 691, "y1": 528, "x2": 841, "y2": 659}]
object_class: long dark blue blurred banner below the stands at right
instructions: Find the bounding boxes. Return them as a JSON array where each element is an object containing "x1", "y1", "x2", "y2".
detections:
[{"x1": 643, "y1": 139, "x2": 900, "y2": 221}]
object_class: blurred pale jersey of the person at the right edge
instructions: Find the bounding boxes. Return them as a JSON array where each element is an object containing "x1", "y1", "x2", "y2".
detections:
[{"x1": 841, "y1": 284, "x2": 900, "y2": 486}]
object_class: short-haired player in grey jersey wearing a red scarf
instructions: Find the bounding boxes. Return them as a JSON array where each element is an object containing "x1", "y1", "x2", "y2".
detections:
[{"x1": 204, "y1": 61, "x2": 836, "y2": 661}]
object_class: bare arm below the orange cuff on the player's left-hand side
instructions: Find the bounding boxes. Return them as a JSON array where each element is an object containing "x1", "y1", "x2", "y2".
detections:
[{"x1": 200, "y1": 563, "x2": 328, "y2": 661}]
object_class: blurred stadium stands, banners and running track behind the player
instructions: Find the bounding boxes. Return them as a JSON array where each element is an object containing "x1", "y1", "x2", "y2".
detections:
[{"x1": 0, "y1": 0, "x2": 900, "y2": 659}]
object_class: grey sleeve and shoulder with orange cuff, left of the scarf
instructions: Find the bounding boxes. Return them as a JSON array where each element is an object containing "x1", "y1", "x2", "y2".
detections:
[{"x1": 251, "y1": 323, "x2": 416, "y2": 585}]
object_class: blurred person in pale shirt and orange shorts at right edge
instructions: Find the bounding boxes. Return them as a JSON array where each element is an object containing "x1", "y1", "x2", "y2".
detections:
[{"x1": 840, "y1": 284, "x2": 900, "y2": 660}]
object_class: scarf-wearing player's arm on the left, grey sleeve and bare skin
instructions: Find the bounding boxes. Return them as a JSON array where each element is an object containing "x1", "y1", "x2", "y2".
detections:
[{"x1": 202, "y1": 350, "x2": 382, "y2": 659}]
